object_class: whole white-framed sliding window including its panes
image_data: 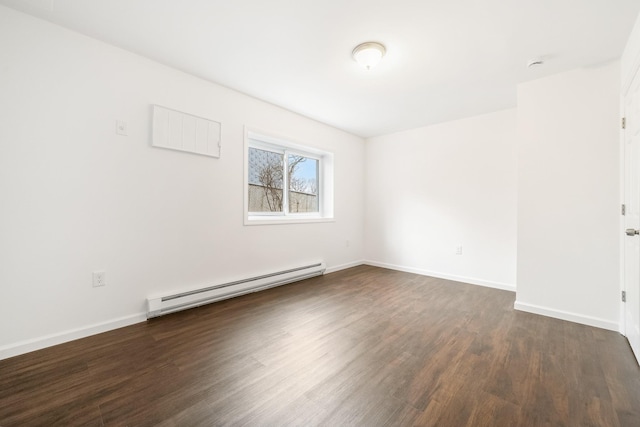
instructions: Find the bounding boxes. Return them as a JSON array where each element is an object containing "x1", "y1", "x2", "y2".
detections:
[{"x1": 245, "y1": 131, "x2": 333, "y2": 224}]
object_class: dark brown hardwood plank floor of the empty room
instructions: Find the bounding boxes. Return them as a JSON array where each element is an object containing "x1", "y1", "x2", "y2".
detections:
[{"x1": 0, "y1": 266, "x2": 640, "y2": 427}]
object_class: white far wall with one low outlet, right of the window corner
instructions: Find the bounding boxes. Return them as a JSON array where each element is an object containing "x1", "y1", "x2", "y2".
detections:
[{"x1": 365, "y1": 109, "x2": 516, "y2": 290}]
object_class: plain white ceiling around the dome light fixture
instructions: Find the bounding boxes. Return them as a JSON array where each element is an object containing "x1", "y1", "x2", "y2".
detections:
[{"x1": 0, "y1": 0, "x2": 640, "y2": 137}]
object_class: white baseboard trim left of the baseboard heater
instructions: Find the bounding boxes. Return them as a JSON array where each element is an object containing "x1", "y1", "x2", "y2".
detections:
[{"x1": 0, "y1": 313, "x2": 147, "y2": 360}]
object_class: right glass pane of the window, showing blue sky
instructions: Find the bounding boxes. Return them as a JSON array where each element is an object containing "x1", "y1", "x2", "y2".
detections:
[{"x1": 287, "y1": 154, "x2": 318, "y2": 213}]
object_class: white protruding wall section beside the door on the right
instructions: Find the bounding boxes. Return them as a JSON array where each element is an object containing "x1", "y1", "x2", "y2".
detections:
[{"x1": 516, "y1": 62, "x2": 620, "y2": 330}]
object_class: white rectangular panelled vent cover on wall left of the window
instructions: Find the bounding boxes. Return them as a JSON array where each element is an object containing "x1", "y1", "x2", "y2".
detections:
[{"x1": 151, "y1": 105, "x2": 221, "y2": 157}]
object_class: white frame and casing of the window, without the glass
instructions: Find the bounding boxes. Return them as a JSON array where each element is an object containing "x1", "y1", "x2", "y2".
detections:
[{"x1": 243, "y1": 128, "x2": 333, "y2": 225}]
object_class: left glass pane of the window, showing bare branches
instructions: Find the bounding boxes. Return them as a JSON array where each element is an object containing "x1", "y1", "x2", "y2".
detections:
[{"x1": 247, "y1": 147, "x2": 284, "y2": 212}]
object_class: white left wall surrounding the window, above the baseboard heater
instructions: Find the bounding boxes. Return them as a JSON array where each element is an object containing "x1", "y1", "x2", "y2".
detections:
[{"x1": 0, "y1": 7, "x2": 364, "y2": 358}]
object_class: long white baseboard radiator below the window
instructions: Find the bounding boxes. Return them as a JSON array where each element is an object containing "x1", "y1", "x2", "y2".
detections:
[{"x1": 147, "y1": 262, "x2": 326, "y2": 319}]
